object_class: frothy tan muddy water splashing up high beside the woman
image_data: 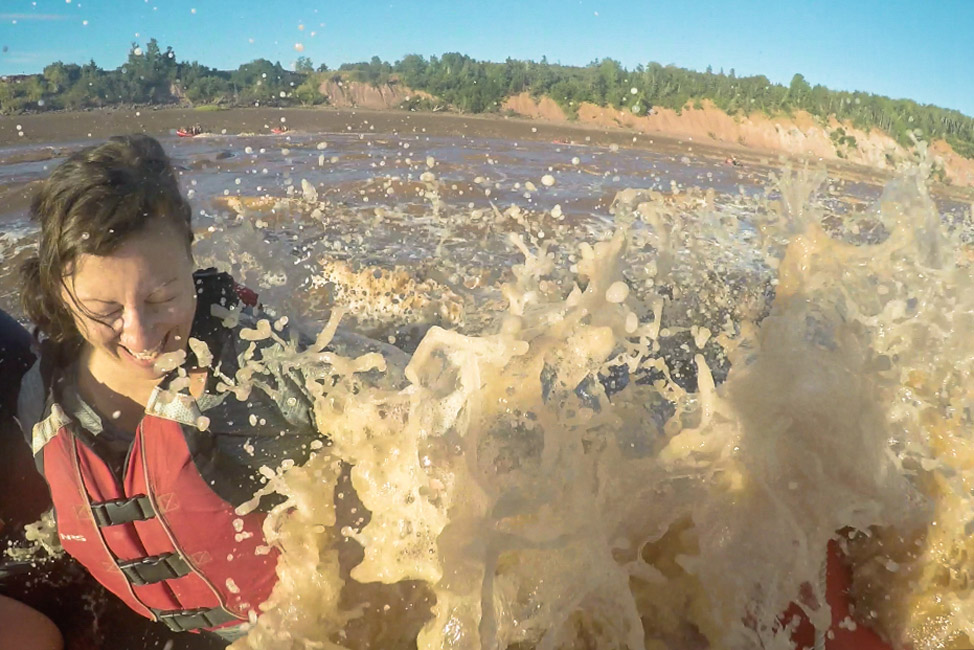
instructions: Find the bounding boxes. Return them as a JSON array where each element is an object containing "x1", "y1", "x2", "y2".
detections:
[{"x1": 1, "y1": 128, "x2": 974, "y2": 650}]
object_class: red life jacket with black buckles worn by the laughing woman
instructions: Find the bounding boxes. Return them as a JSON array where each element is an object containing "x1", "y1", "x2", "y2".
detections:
[{"x1": 35, "y1": 402, "x2": 278, "y2": 631}]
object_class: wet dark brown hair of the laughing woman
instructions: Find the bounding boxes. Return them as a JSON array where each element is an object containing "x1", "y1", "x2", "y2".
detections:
[{"x1": 20, "y1": 135, "x2": 193, "y2": 348}]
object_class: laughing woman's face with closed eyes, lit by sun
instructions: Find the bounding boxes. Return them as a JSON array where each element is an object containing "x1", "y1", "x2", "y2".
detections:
[{"x1": 62, "y1": 219, "x2": 196, "y2": 381}]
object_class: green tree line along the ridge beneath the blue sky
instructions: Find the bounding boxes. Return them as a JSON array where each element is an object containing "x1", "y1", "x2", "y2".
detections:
[{"x1": 0, "y1": 39, "x2": 974, "y2": 158}]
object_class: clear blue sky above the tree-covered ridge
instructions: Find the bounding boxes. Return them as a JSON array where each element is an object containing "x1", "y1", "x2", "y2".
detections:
[{"x1": 0, "y1": 0, "x2": 974, "y2": 116}]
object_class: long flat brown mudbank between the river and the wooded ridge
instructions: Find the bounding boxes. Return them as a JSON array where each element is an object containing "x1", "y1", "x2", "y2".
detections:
[{"x1": 0, "y1": 106, "x2": 974, "y2": 201}]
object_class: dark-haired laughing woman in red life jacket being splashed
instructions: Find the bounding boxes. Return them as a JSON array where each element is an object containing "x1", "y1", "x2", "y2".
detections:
[{"x1": 12, "y1": 135, "x2": 400, "y2": 642}]
